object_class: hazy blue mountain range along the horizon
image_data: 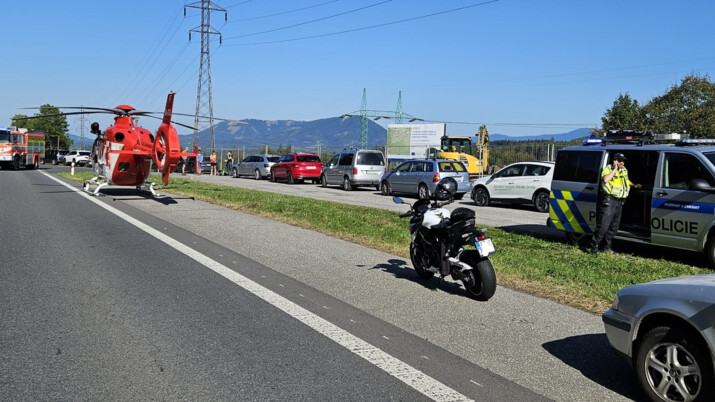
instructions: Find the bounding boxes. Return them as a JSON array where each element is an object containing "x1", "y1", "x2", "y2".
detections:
[{"x1": 70, "y1": 117, "x2": 590, "y2": 149}]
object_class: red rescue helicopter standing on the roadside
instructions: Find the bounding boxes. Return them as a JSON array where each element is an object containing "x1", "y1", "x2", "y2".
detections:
[{"x1": 16, "y1": 92, "x2": 198, "y2": 197}]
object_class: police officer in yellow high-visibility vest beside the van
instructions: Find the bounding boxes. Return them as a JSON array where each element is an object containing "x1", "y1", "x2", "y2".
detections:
[{"x1": 591, "y1": 152, "x2": 640, "y2": 254}]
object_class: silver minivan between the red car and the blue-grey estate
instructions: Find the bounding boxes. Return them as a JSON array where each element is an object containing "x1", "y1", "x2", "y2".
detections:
[{"x1": 320, "y1": 149, "x2": 386, "y2": 191}]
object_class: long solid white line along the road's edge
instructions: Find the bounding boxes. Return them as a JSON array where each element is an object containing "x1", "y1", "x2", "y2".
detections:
[{"x1": 40, "y1": 172, "x2": 471, "y2": 401}]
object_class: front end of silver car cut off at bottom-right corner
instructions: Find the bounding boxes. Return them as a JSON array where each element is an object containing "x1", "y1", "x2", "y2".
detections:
[{"x1": 602, "y1": 274, "x2": 715, "y2": 401}]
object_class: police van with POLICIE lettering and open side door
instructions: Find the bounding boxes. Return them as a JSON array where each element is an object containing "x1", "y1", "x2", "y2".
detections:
[{"x1": 547, "y1": 130, "x2": 715, "y2": 267}]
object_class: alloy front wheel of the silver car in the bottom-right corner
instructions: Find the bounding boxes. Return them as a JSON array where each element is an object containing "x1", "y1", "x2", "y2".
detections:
[{"x1": 635, "y1": 326, "x2": 715, "y2": 401}]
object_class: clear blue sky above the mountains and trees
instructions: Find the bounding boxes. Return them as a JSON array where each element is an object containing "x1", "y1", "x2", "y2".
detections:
[{"x1": 0, "y1": 0, "x2": 715, "y2": 136}]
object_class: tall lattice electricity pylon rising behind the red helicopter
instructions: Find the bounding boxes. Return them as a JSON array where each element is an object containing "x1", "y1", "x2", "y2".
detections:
[{"x1": 184, "y1": 0, "x2": 228, "y2": 150}]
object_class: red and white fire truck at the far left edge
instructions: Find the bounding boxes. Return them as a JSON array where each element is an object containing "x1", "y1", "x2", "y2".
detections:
[{"x1": 0, "y1": 127, "x2": 45, "y2": 170}]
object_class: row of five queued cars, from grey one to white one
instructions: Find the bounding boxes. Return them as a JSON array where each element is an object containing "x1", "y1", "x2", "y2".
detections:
[{"x1": 215, "y1": 148, "x2": 554, "y2": 212}]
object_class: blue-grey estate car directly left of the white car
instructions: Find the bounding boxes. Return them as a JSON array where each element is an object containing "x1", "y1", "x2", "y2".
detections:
[{"x1": 380, "y1": 159, "x2": 472, "y2": 200}]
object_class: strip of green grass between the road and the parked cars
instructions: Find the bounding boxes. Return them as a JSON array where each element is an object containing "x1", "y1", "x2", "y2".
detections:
[{"x1": 60, "y1": 172, "x2": 712, "y2": 313}]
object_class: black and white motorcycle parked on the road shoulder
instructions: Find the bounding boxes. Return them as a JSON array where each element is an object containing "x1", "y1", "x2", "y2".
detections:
[{"x1": 392, "y1": 177, "x2": 497, "y2": 301}]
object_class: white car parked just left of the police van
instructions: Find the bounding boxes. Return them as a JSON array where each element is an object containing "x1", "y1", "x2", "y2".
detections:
[{"x1": 472, "y1": 162, "x2": 554, "y2": 212}]
